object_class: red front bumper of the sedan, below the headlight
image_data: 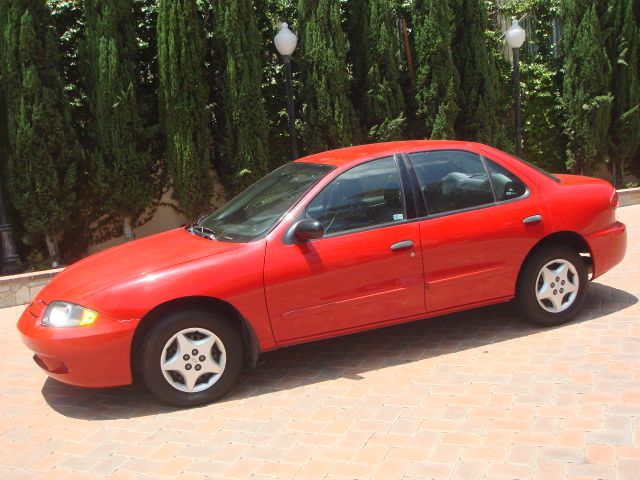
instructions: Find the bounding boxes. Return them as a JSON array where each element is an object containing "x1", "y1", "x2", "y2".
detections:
[{"x1": 18, "y1": 300, "x2": 137, "y2": 388}]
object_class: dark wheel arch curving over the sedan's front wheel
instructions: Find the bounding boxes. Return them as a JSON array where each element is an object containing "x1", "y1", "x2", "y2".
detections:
[{"x1": 130, "y1": 296, "x2": 260, "y2": 376}]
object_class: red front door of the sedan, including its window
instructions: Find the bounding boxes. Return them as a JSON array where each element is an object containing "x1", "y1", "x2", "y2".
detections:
[{"x1": 265, "y1": 157, "x2": 425, "y2": 342}]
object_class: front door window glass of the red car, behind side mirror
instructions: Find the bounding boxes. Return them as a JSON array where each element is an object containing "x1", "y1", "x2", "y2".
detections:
[{"x1": 306, "y1": 157, "x2": 406, "y2": 235}]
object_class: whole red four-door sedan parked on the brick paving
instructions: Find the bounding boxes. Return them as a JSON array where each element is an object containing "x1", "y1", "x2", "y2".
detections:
[{"x1": 18, "y1": 141, "x2": 626, "y2": 406}]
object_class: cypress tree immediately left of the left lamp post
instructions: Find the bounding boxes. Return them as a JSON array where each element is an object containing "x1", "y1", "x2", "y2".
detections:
[{"x1": 212, "y1": 0, "x2": 269, "y2": 193}]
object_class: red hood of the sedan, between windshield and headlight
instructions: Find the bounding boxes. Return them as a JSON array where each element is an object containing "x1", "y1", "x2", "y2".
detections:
[{"x1": 38, "y1": 228, "x2": 244, "y2": 303}]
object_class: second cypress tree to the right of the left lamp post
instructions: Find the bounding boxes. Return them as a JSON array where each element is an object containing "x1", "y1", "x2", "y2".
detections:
[{"x1": 362, "y1": 0, "x2": 406, "y2": 141}]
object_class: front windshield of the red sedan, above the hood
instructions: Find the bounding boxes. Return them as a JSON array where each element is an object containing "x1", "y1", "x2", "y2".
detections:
[{"x1": 198, "y1": 162, "x2": 333, "y2": 242}]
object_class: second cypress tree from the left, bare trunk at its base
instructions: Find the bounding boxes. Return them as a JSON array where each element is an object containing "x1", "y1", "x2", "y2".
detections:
[{"x1": 84, "y1": 0, "x2": 152, "y2": 240}]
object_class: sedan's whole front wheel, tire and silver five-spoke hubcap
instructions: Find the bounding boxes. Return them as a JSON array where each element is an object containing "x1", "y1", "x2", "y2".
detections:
[{"x1": 140, "y1": 309, "x2": 243, "y2": 407}]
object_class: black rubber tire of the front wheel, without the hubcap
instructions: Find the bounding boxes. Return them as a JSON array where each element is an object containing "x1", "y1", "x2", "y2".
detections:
[{"x1": 139, "y1": 308, "x2": 243, "y2": 407}]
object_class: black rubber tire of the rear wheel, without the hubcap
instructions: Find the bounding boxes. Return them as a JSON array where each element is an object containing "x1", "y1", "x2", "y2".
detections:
[{"x1": 516, "y1": 244, "x2": 589, "y2": 327}]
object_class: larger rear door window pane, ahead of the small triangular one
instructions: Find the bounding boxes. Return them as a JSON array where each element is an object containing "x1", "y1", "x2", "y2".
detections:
[{"x1": 409, "y1": 150, "x2": 495, "y2": 215}]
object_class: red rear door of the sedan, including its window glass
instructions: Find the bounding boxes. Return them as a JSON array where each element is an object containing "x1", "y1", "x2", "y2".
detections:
[{"x1": 408, "y1": 150, "x2": 548, "y2": 312}]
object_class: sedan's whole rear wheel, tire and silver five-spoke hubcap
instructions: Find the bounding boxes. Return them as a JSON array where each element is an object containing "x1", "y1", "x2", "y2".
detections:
[{"x1": 516, "y1": 245, "x2": 589, "y2": 326}]
